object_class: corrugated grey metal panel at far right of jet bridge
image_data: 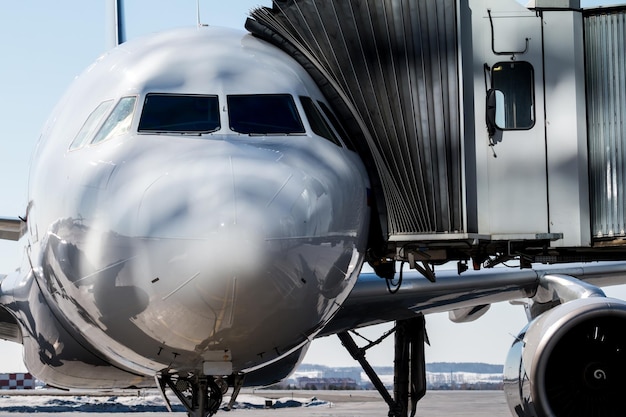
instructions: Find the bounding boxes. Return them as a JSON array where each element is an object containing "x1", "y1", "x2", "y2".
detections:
[{"x1": 585, "y1": 7, "x2": 626, "y2": 238}]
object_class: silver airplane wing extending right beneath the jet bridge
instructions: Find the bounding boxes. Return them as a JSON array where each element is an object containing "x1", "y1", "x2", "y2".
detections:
[{"x1": 320, "y1": 262, "x2": 626, "y2": 336}]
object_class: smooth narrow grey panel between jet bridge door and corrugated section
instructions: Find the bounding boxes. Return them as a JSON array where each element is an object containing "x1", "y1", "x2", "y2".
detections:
[{"x1": 542, "y1": 10, "x2": 591, "y2": 247}]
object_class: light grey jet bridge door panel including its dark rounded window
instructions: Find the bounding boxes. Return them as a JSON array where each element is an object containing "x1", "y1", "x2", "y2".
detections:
[{"x1": 461, "y1": 0, "x2": 549, "y2": 240}]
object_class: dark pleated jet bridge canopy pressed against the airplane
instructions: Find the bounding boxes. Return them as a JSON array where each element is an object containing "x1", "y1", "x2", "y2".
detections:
[{"x1": 248, "y1": 0, "x2": 464, "y2": 235}]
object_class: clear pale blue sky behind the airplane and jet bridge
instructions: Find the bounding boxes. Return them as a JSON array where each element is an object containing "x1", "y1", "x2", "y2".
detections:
[{"x1": 0, "y1": 0, "x2": 613, "y2": 372}]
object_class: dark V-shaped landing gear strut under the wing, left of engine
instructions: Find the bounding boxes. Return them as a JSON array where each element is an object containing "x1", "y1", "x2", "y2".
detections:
[{"x1": 337, "y1": 316, "x2": 427, "y2": 417}]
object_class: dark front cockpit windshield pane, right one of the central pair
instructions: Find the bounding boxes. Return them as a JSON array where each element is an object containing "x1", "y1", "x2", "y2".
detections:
[{"x1": 227, "y1": 94, "x2": 306, "y2": 135}]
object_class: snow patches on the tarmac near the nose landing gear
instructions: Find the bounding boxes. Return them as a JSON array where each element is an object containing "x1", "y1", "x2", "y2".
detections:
[{"x1": 0, "y1": 390, "x2": 328, "y2": 414}]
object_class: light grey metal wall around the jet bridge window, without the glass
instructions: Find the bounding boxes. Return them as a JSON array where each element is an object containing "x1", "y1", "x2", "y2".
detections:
[{"x1": 463, "y1": 0, "x2": 544, "y2": 237}]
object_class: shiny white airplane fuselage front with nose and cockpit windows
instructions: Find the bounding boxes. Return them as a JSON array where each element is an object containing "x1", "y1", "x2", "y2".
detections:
[{"x1": 3, "y1": 28, "x2": 369, "y2": 387}]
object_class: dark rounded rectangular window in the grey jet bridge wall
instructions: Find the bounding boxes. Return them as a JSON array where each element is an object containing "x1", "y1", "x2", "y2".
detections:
[{"x1": 491, "y1": 61, "x2": 535, "y2": 130}]
